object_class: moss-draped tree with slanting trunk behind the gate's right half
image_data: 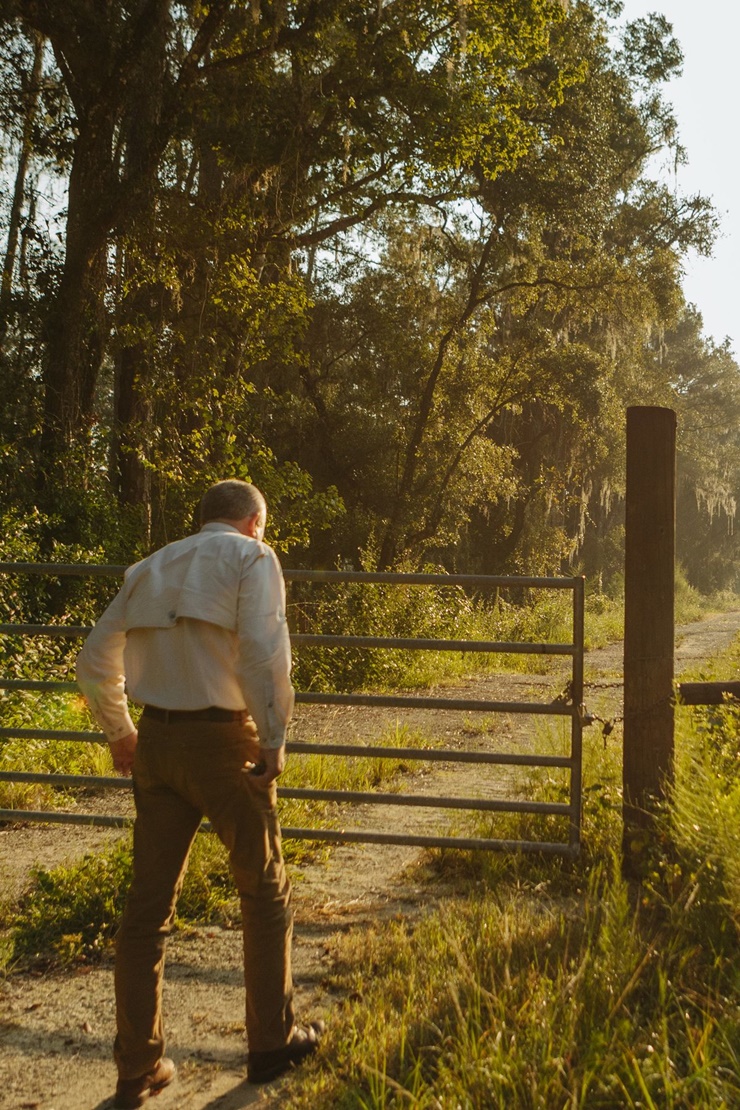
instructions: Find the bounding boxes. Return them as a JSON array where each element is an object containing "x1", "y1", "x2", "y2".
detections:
[{"x1": 251, "y1": 4, "x2": 712, "y2": 572}]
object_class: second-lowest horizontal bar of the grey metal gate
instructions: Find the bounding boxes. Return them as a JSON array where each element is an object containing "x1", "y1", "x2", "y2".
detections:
[{"x1": 0, "y1": 770, "x2": 570, "y2": 817}]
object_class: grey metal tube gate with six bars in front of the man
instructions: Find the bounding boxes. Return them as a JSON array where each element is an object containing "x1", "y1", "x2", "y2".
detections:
[{"x1": 0, "y1": 563, "x2": 588, "y2": 856}]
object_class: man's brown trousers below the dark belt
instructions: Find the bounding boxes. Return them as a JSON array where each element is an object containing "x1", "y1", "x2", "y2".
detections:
[{"x1": 114, "y1": 717, "x2": 294, "y2": 1079}]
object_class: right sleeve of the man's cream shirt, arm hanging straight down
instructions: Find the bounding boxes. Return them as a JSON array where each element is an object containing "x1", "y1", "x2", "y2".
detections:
[{"x1": 236, "y1": 545, "x2": 295, "y2": 748}]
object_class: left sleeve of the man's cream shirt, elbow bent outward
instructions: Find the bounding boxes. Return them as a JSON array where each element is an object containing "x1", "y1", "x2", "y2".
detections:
[{"x1": 77, "y1": 589, "x2": 135, "y2": 741}]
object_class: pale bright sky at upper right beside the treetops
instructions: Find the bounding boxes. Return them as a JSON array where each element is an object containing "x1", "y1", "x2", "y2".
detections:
[{"x1": 621, "y1": 0, "x2": 740, "y2": 355}]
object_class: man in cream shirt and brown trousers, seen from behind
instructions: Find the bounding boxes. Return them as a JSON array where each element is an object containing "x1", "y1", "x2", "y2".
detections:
[{"x1": 77, "y1": 481, "x2": 323, "y2": 1110}]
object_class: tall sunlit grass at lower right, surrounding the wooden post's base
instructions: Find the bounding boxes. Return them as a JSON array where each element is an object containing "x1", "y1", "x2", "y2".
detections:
[{"x1": 285, "y1": 679, "x2": 740, "y2": 1110}]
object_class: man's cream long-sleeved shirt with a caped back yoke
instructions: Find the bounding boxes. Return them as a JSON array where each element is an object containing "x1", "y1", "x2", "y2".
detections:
[{"x1": 77, "y1": 522, "x2": 294, "y2": 748}]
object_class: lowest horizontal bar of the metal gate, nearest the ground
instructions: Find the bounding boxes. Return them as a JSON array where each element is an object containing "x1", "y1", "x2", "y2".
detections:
[{"x1": 0, "y1": 809, "x2": 578, "y2": 856}]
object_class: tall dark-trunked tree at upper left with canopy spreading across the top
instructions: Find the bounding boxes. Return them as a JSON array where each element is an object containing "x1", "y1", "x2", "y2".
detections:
[{"x1": 0, "y1": 0, "x2": 572, "y2": 488}]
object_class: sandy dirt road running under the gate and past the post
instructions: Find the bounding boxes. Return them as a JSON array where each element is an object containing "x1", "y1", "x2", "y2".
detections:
[{"x1": 0, "y1": 613, "x2": 740, "y2": 1110}]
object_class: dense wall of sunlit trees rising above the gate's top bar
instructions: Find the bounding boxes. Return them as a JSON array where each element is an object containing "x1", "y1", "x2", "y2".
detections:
[{"x1": 0, "y1": 0, "x2": 738, "y2": 591}]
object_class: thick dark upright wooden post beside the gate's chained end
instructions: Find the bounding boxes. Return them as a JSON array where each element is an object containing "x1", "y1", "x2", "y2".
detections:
[{"x1": 622, "y1": 407, "x2": 676, "y2": 874}]
